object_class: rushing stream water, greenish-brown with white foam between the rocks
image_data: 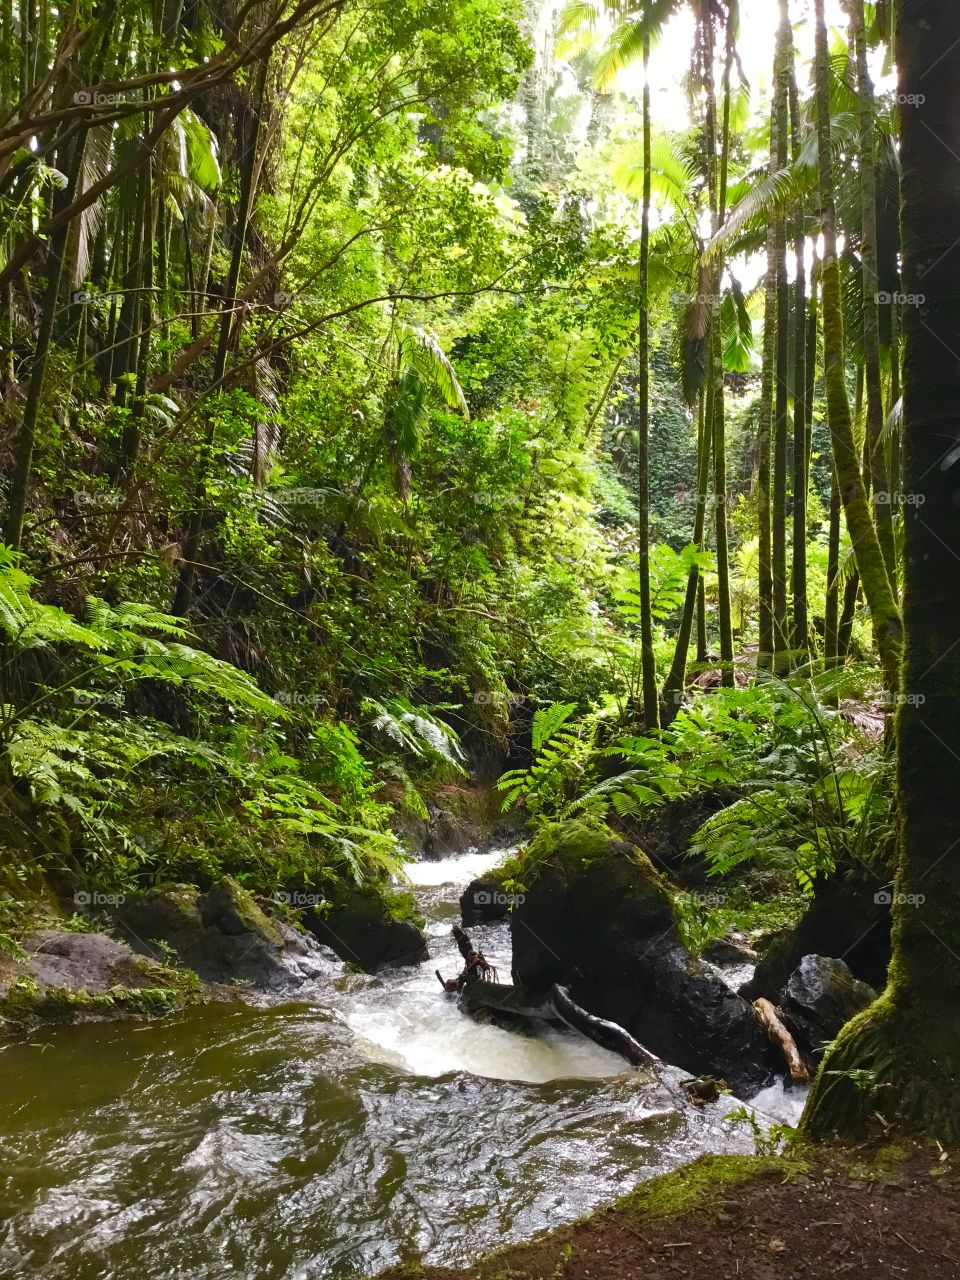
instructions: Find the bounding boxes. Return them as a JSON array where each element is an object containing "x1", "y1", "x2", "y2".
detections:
[{"x1": 0, "y1": 852, "x2": 814, "y2": 1280}]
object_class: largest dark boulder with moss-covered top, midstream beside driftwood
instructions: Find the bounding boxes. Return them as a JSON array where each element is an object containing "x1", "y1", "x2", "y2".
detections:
[{"x1": 511, "y1": 822, "x2": 776, "y2": 1094}]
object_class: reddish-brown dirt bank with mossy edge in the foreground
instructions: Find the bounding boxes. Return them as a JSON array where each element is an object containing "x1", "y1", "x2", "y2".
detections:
[{"x1": 392, "y1": 1147, "x2": 960, "y2": 1280}]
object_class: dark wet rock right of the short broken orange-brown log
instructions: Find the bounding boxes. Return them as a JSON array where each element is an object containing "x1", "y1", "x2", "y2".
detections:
[{"x1": 780, "y1": 956, "x2": 877, "y2": 1065}]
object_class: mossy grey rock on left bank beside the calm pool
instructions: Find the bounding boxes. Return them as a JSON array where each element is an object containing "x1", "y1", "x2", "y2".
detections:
[{"x1": 114, "y1": 877, "x2": 325, "y2": 991}]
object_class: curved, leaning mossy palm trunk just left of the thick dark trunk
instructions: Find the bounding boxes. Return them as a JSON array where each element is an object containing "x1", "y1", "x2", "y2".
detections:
[{"x1": 814, "y1": 0, "x2": 901, "y2": 691}]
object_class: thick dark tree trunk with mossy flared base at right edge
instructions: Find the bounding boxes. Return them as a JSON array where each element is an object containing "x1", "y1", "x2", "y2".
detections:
[{"x1": 804, "y1": 0, "x2": 960, "y2": 1143}]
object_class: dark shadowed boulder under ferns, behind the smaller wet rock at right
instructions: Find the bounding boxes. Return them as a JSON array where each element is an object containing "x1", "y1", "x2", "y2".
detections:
[{"x1": 740, "y1": 867, "x2": 890, "y2": 1002}]
